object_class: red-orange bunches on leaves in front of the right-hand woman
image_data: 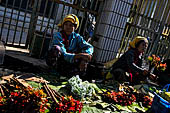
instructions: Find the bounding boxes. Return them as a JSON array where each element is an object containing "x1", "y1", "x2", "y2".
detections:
[{"x1": 102, "y1": 86, "x2": 152, "y2": 107}]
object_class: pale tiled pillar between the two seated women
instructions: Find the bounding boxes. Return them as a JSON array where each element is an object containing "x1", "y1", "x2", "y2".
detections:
[{"x1": 93, "y1": 0, "x2": 133, "y2": 62}]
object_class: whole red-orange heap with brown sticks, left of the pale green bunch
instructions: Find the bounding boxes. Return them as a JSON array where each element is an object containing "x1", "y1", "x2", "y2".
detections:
[{"x1": 0, "y1": 77, "x2": 83, "y2": 113}]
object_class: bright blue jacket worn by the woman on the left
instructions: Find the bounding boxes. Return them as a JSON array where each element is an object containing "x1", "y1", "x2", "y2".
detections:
[{"x1": 51, "y1": 32, "x2": 94, "y2": 63}]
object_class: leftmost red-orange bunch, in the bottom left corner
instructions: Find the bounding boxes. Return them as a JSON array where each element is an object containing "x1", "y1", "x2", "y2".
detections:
[{"x1": 0, "y1": 78, "x2": 49, "y2": 113}]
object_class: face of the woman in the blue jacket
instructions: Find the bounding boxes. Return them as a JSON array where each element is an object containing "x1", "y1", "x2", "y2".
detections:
[{"x1": 63, "y1": 21, "x2": 75, "y2": 35}]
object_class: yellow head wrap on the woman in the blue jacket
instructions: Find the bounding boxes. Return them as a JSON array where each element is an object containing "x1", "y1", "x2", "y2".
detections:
[{"x1": 58, "y1": 14, "x2": 79, "y2": 29}]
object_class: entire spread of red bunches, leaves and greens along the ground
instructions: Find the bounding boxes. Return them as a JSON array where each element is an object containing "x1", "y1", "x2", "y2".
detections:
[{"x1": 0, "y1": 75, "x2": 163, "y2": 113}]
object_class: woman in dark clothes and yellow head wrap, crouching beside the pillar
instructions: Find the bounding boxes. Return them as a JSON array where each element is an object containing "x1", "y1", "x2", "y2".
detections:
[{"x1": 110, "y1": 36, "x2": 155, "y2": 83}]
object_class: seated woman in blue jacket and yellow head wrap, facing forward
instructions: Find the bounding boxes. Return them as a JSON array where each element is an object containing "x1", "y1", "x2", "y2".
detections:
[{"x1": 46, "y1": 14, "x2": 93, "y2": 76}]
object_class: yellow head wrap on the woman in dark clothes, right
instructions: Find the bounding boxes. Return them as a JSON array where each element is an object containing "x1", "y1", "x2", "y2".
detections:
[{"x1": 129, "y1": 36, "x2": 148, "y2": 48}]
